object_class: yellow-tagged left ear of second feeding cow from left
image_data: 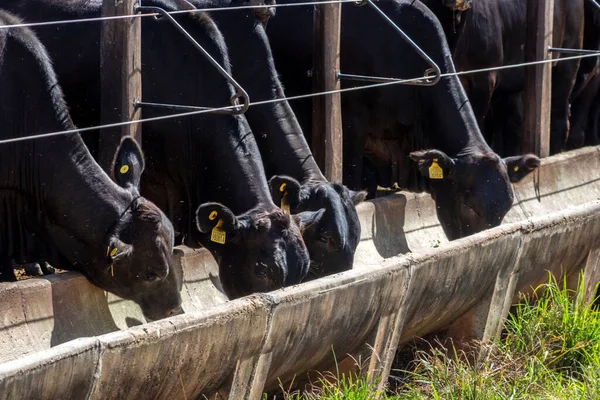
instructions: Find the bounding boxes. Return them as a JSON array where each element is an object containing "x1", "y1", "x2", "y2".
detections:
[{"x1": 196, "y1": 203, "x2": 239, "y2": 244}]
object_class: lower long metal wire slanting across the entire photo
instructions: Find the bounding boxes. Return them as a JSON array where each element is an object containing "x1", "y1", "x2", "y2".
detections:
[{"x1": 0, "y1": 52, "x2": 600, "y2": 144}]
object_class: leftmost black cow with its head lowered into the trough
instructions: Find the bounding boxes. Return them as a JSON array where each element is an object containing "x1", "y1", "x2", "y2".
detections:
[{"x1": 0, "y1": 12, "x2": 181, "y2": 320}]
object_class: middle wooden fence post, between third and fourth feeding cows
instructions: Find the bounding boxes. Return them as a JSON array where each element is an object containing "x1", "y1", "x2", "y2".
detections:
[{"x1": 312, "y1": 3, "x2": 343, "y2": 182}]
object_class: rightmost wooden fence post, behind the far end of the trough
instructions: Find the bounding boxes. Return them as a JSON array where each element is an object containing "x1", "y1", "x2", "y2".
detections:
[{"x1": 521, "y1": 0, "x2": 554, "y2": 157}]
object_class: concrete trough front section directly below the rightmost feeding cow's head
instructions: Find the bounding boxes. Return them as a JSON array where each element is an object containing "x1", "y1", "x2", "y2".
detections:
[{"x1": 400, "y1": 224, "x2": 521, "y2": 342}]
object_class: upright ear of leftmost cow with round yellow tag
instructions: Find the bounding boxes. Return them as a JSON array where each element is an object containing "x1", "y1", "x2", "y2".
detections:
[{"x1": 113, "y1": 136, "x2": 146, "y2": 190}]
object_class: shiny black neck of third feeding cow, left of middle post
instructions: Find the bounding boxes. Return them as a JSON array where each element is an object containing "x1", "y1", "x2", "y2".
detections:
[{"x1": 216, "y1": 11, "x2": 327, "y2": 183}]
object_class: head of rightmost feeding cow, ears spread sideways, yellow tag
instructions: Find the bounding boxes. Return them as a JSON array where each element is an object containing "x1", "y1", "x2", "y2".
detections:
[{"x1": 410, "y1": 150, "x2": 540, "y2": 240}]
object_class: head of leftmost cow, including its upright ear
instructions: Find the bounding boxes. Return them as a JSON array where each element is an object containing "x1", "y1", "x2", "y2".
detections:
[{"x1": 94, "y1": 137, "x2": 182, "y2": 320}]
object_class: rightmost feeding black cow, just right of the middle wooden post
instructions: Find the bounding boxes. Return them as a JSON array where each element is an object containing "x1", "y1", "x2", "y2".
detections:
[{"x1": 267, "y1": 1, "x2": 539, "y2": 239}]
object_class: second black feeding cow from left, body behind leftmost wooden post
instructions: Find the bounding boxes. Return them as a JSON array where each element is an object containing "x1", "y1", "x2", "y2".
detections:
[{"x1": 4, "y1": 0, "x2": 309, "y2": 298}]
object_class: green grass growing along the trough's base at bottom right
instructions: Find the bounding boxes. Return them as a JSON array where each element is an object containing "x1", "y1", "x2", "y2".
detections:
[{"x1": 278, "y1": 278, "x2": 600, "y2": 400}]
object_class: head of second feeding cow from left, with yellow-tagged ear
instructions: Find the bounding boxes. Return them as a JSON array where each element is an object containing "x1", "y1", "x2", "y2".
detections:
[{"x1": 196, "y1": 203, "x2": 309, "y2": 299}]
